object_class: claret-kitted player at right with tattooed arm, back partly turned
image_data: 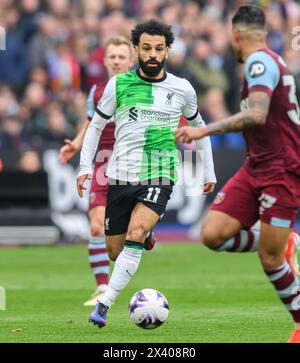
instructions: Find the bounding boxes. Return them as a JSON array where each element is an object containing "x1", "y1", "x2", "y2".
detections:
[{"x1": 176, "y1": 5, "x2": 300, "y2": 343}]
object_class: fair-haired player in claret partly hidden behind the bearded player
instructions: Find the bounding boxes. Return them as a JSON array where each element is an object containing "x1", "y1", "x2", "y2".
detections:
[{"x1": 59, "y1": 36, "x2": 133, "y2": 306}]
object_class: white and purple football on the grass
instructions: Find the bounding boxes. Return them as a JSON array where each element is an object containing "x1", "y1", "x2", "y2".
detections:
[{"x1": 129, "y1": 289, "x2": 169, "y2": 329}]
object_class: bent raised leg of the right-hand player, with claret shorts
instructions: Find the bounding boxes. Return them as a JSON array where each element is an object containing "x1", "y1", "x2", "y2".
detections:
[{"x1": 201, "y1": 167, "x2": 259, "y2": 252}]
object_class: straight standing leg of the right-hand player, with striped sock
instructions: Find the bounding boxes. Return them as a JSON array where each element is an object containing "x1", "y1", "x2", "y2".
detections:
[{"x1": 258, "y1": 223, "x2": 300, "y2": 342}]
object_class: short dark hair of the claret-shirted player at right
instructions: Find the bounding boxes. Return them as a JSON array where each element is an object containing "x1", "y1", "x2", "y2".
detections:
[{"x1": 232, "y1": 5, "x2": 266, "y2": 28}]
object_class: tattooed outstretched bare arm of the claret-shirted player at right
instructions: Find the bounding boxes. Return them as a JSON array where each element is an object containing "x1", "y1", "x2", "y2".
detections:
[{"x1": 175, "y1": 91, "x2": 271, "y2": 143}]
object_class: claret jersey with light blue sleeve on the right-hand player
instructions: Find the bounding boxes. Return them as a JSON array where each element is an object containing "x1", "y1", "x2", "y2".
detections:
[{"x1": 241, "y1": 49, "x2": 300, "y2": 176}]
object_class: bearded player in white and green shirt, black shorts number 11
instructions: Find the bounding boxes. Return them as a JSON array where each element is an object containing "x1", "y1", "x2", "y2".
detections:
[{"x1": 77, "y1": 20, "x2": 216, "y2": 328}]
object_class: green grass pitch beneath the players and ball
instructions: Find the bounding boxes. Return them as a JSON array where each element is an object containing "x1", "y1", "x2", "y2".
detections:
[{"x1": 0, "y1": 243, "x2": 293, "y2": 343}]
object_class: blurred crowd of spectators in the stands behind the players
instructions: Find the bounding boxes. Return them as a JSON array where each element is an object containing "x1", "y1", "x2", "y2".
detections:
[{"x1": 0, "y1": 0, "x2": 300, "y2": 171}]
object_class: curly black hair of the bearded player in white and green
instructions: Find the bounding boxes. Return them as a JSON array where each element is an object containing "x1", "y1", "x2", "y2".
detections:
[{"x1": 131, "y1": 19, "x2": 174, "y2": 47}]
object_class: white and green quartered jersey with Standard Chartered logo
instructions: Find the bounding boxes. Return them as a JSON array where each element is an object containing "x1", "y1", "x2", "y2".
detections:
[{"x1": 96, "y1": 71, "x2": 198, "y2": 182}]
